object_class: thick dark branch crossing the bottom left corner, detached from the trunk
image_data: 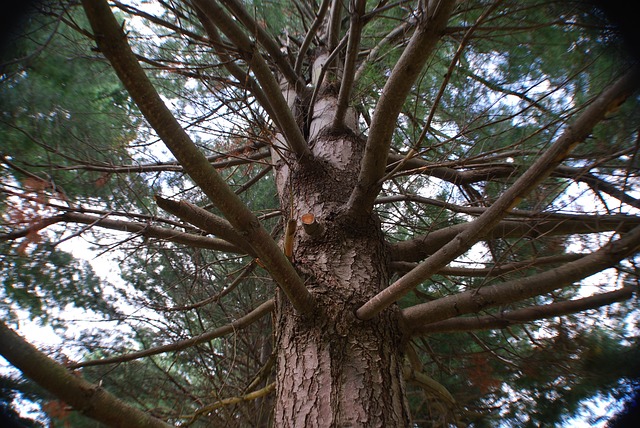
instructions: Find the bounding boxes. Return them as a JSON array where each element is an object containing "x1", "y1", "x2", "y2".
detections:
[{"x1": 0, "y1": 321, "x2": 170, "y2": 428}]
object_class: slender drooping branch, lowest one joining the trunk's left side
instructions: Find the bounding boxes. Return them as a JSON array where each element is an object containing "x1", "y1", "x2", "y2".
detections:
[{"x1": 69, "y1": 299, "x2": 274, "y2": 369}]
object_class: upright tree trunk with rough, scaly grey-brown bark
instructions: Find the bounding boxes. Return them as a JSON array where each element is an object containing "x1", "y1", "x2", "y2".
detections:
[{"x1": 273, "y1": 68, "x2": 409, "y2": 427}]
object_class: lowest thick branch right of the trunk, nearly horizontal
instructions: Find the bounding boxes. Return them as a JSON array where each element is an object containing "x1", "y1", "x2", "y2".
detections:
[{"x1": 411, "y1": 287, "x2": 637, "y2": 336}]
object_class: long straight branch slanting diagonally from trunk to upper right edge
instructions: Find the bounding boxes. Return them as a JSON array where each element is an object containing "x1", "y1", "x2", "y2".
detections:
[{"x1": 357, "y1": 67, "x2": 640, "y2": 319}]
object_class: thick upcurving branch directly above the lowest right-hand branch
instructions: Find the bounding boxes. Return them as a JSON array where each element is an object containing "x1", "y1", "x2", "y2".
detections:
[{"x1": 402, "y1": 226, "x2": 640, "y2": 325}]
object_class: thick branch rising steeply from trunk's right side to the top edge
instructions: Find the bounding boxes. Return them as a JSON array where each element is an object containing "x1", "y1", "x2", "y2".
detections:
[{"x1": 348, "y1": 0, "x2": 456, "y2": 215}]
